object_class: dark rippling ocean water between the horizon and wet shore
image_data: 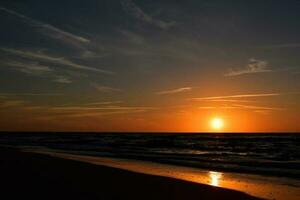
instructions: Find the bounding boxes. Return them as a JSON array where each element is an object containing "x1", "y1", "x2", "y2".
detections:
[{"x1": 0, "y1": 132, "x2": 300, "y2": 180}]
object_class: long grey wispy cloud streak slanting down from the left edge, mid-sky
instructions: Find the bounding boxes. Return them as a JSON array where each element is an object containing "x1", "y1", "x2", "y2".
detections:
[{"x1": 0, "y1": 48, "x2": 113, "y2": 75}]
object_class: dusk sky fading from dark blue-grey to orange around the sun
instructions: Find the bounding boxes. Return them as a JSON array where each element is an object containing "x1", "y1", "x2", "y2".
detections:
[{"x1": 0, "y1": 0, "x2": 300, "y2": 132}]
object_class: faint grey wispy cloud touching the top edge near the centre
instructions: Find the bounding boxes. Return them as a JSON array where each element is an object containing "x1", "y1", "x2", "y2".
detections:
[{"x1": 121, "y1": 0, "x2": 176, "y2": 30}]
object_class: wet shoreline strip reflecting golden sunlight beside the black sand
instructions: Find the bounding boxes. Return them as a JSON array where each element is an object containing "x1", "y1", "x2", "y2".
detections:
[{"x1": 36, "y1": 148, "x2": 300, "y2": 200}]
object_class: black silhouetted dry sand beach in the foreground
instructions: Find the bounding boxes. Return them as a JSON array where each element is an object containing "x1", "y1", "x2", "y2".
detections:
[{"x1": 0, "y1": 148, "x2": 258, "y2": 200}]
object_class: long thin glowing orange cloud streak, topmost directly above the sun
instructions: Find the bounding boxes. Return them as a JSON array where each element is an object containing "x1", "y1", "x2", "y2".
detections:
[{"x1": 192, "y1": 93, "x2": 282, "y2": 101}]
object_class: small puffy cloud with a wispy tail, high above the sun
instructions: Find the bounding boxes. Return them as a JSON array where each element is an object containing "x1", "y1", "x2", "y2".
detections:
[{"x1": 224, "y1": 58, "x2": 272, "y2": 76}]
